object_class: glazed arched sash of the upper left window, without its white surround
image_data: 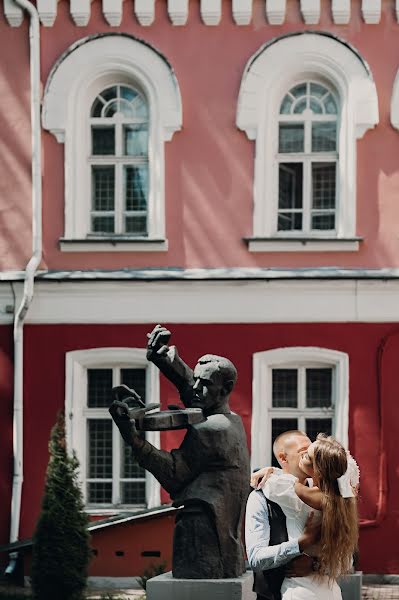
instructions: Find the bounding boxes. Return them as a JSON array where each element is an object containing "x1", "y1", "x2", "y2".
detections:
[{"x1": 89, "y1": 85, "x2": 149, "y2": 236}]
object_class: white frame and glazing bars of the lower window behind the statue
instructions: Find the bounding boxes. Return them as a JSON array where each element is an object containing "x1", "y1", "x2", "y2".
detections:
[{"x1": 65, "y1": 348, "x2": 160, "y2": 514}]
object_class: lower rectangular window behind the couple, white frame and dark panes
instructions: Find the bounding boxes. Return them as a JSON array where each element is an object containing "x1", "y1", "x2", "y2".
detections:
[{"x1": 251, "y1": 346, "x2": 349, "y2": 468}]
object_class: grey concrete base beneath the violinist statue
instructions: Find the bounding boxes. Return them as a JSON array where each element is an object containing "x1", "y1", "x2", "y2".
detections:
[{"x1": 146, "y1": 571, "x2": 256, "y2": 600}]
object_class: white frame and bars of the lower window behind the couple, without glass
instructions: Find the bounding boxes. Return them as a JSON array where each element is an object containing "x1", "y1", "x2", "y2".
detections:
[{"x1": 251, "y1": 346, "x2": 349, "y2": 468}]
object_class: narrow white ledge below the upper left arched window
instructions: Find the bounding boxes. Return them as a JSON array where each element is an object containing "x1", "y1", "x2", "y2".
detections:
[{"x1": 59, "y1": 237, "x2": 168, "y2": 252}]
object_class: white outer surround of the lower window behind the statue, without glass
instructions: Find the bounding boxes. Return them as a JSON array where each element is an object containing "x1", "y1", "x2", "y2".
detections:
[{"x1": 65, "y1": 348, "x2": 161, "y2": 515}]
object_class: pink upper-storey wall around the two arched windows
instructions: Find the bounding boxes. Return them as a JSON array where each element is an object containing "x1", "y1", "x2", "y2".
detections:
[{"x1": 0, "y1": 0, "x2": 399, "y2": 269}]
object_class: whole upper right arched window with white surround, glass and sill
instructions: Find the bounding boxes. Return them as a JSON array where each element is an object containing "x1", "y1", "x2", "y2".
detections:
[{"x1": 237, "y1": 32, "x2": 378, "y2": 252}]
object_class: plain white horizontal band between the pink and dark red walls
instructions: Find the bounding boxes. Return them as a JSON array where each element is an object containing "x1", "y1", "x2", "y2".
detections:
[{"x1": 0, "y1": 279, "x2": 399, "y2": 324}]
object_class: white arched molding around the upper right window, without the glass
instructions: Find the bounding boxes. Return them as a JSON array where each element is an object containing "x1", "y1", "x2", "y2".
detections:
[{"x1": 237, "y1": 32, "x2": 378, "y2": 251}]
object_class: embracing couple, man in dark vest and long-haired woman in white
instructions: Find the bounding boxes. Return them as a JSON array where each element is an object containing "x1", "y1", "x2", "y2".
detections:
[{"x1": 245, "y1": 431, "x2": 359, "y2": 600}]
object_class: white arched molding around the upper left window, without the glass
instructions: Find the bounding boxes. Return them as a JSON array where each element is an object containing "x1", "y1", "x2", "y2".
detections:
[{"x1": 43, "y1": 34, "x2": 182, "y2": 251}]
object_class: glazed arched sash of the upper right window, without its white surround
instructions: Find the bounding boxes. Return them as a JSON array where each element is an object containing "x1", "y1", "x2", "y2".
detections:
[{"x1": 277, "y1": 81, "x2": 338, "y2": 235}]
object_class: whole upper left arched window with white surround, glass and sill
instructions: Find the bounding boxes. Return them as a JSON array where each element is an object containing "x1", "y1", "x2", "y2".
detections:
[{"x1": 42, "y1": 34, "x2": 182, "y2": 252}]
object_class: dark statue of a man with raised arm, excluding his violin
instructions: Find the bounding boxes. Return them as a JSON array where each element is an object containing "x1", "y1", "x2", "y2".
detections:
[{"x1": 110, "y1": 325, "x2": 250, "y2": 579}]
